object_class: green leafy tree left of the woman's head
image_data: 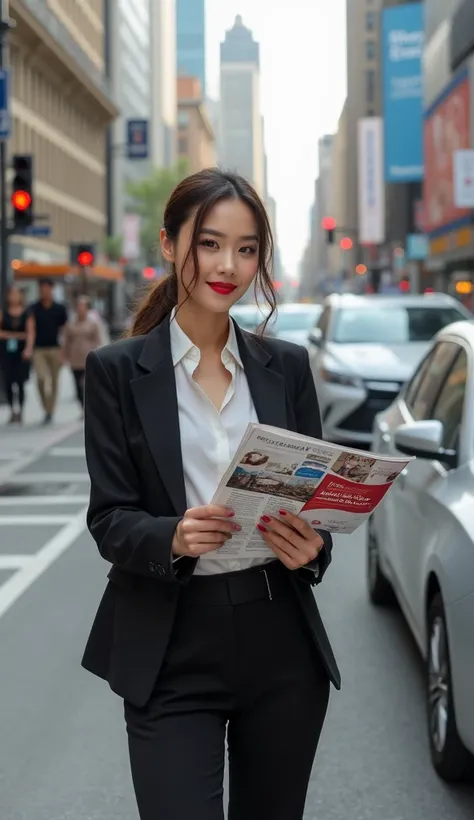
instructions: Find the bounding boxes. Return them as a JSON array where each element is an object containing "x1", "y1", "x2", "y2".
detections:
[{"x1": 127, "y1": 160, "x2": 188, "y2": 265}]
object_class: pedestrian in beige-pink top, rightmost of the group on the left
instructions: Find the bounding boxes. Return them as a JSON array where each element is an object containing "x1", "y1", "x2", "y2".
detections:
[{"x1": 63, "y1": 296, "x2": 101, "y2": 408}]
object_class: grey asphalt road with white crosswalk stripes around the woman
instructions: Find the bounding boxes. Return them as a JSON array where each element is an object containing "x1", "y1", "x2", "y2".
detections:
[{"x1": 0, "y1": 435, "x2": 474, "y2": 820}]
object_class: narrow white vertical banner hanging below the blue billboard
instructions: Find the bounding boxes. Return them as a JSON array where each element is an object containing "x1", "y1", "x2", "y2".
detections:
[{"x1": 358, "y1": 117, "x2": 385, "y2": 245}]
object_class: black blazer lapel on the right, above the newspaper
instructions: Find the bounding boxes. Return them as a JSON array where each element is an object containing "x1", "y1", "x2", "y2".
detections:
[{"x1": 234, "y1": 322, "x2": 289, "y2": 429}]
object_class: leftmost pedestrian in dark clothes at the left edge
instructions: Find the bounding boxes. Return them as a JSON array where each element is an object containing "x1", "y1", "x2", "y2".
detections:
[{"x1": 0, "y1": 285, "x2": 35, "y2": 424}]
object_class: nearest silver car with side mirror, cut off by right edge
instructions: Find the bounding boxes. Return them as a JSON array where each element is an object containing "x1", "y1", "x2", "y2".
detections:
[{"x1": 367, "y1": 321, "x2": 474, "y2": 781}]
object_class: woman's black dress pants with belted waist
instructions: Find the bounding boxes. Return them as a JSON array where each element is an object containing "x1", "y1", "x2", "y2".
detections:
[{"x1": 125, "y1": 562, "x2": 329, "y2": 820}]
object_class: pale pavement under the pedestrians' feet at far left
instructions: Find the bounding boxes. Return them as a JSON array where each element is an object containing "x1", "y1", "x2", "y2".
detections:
[{"x1": 0, "y1": 368, "x2": 82, "y2": 470}]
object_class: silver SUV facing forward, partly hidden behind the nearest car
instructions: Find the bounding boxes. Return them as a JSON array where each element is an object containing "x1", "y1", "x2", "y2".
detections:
[{"x1": 309, "y1": 294, "x2": 472, "y2": 445}]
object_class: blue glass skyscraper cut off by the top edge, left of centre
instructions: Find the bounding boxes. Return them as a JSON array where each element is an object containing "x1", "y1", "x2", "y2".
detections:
[{"x1": 176, "y1": 0, "x2": 206, "y2": 93}]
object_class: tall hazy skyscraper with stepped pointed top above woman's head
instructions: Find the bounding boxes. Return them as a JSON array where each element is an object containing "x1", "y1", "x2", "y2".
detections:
[{"x1": 220, "y1": 15, "x2": 265, "y2": 196}]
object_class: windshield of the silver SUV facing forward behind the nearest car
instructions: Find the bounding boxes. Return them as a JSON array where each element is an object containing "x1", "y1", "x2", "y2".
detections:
[{"x1": 332, "y1": 305, "x2": 466, "y2": 344}]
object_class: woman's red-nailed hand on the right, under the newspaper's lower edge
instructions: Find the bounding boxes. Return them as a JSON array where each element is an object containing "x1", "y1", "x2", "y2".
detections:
[{"x1": 257, "y1": 510, "x2": 324, "y2": 569}]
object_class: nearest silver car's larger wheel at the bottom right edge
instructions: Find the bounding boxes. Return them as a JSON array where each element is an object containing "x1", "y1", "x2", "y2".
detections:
[{"x1": 426, "y1": 593, "x2": 471, "y2": 783}]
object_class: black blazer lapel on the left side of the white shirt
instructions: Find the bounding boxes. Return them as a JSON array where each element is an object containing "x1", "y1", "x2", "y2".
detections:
[{"x1": 130, "y1": 318, "x2": 186, "y2": 515}]
